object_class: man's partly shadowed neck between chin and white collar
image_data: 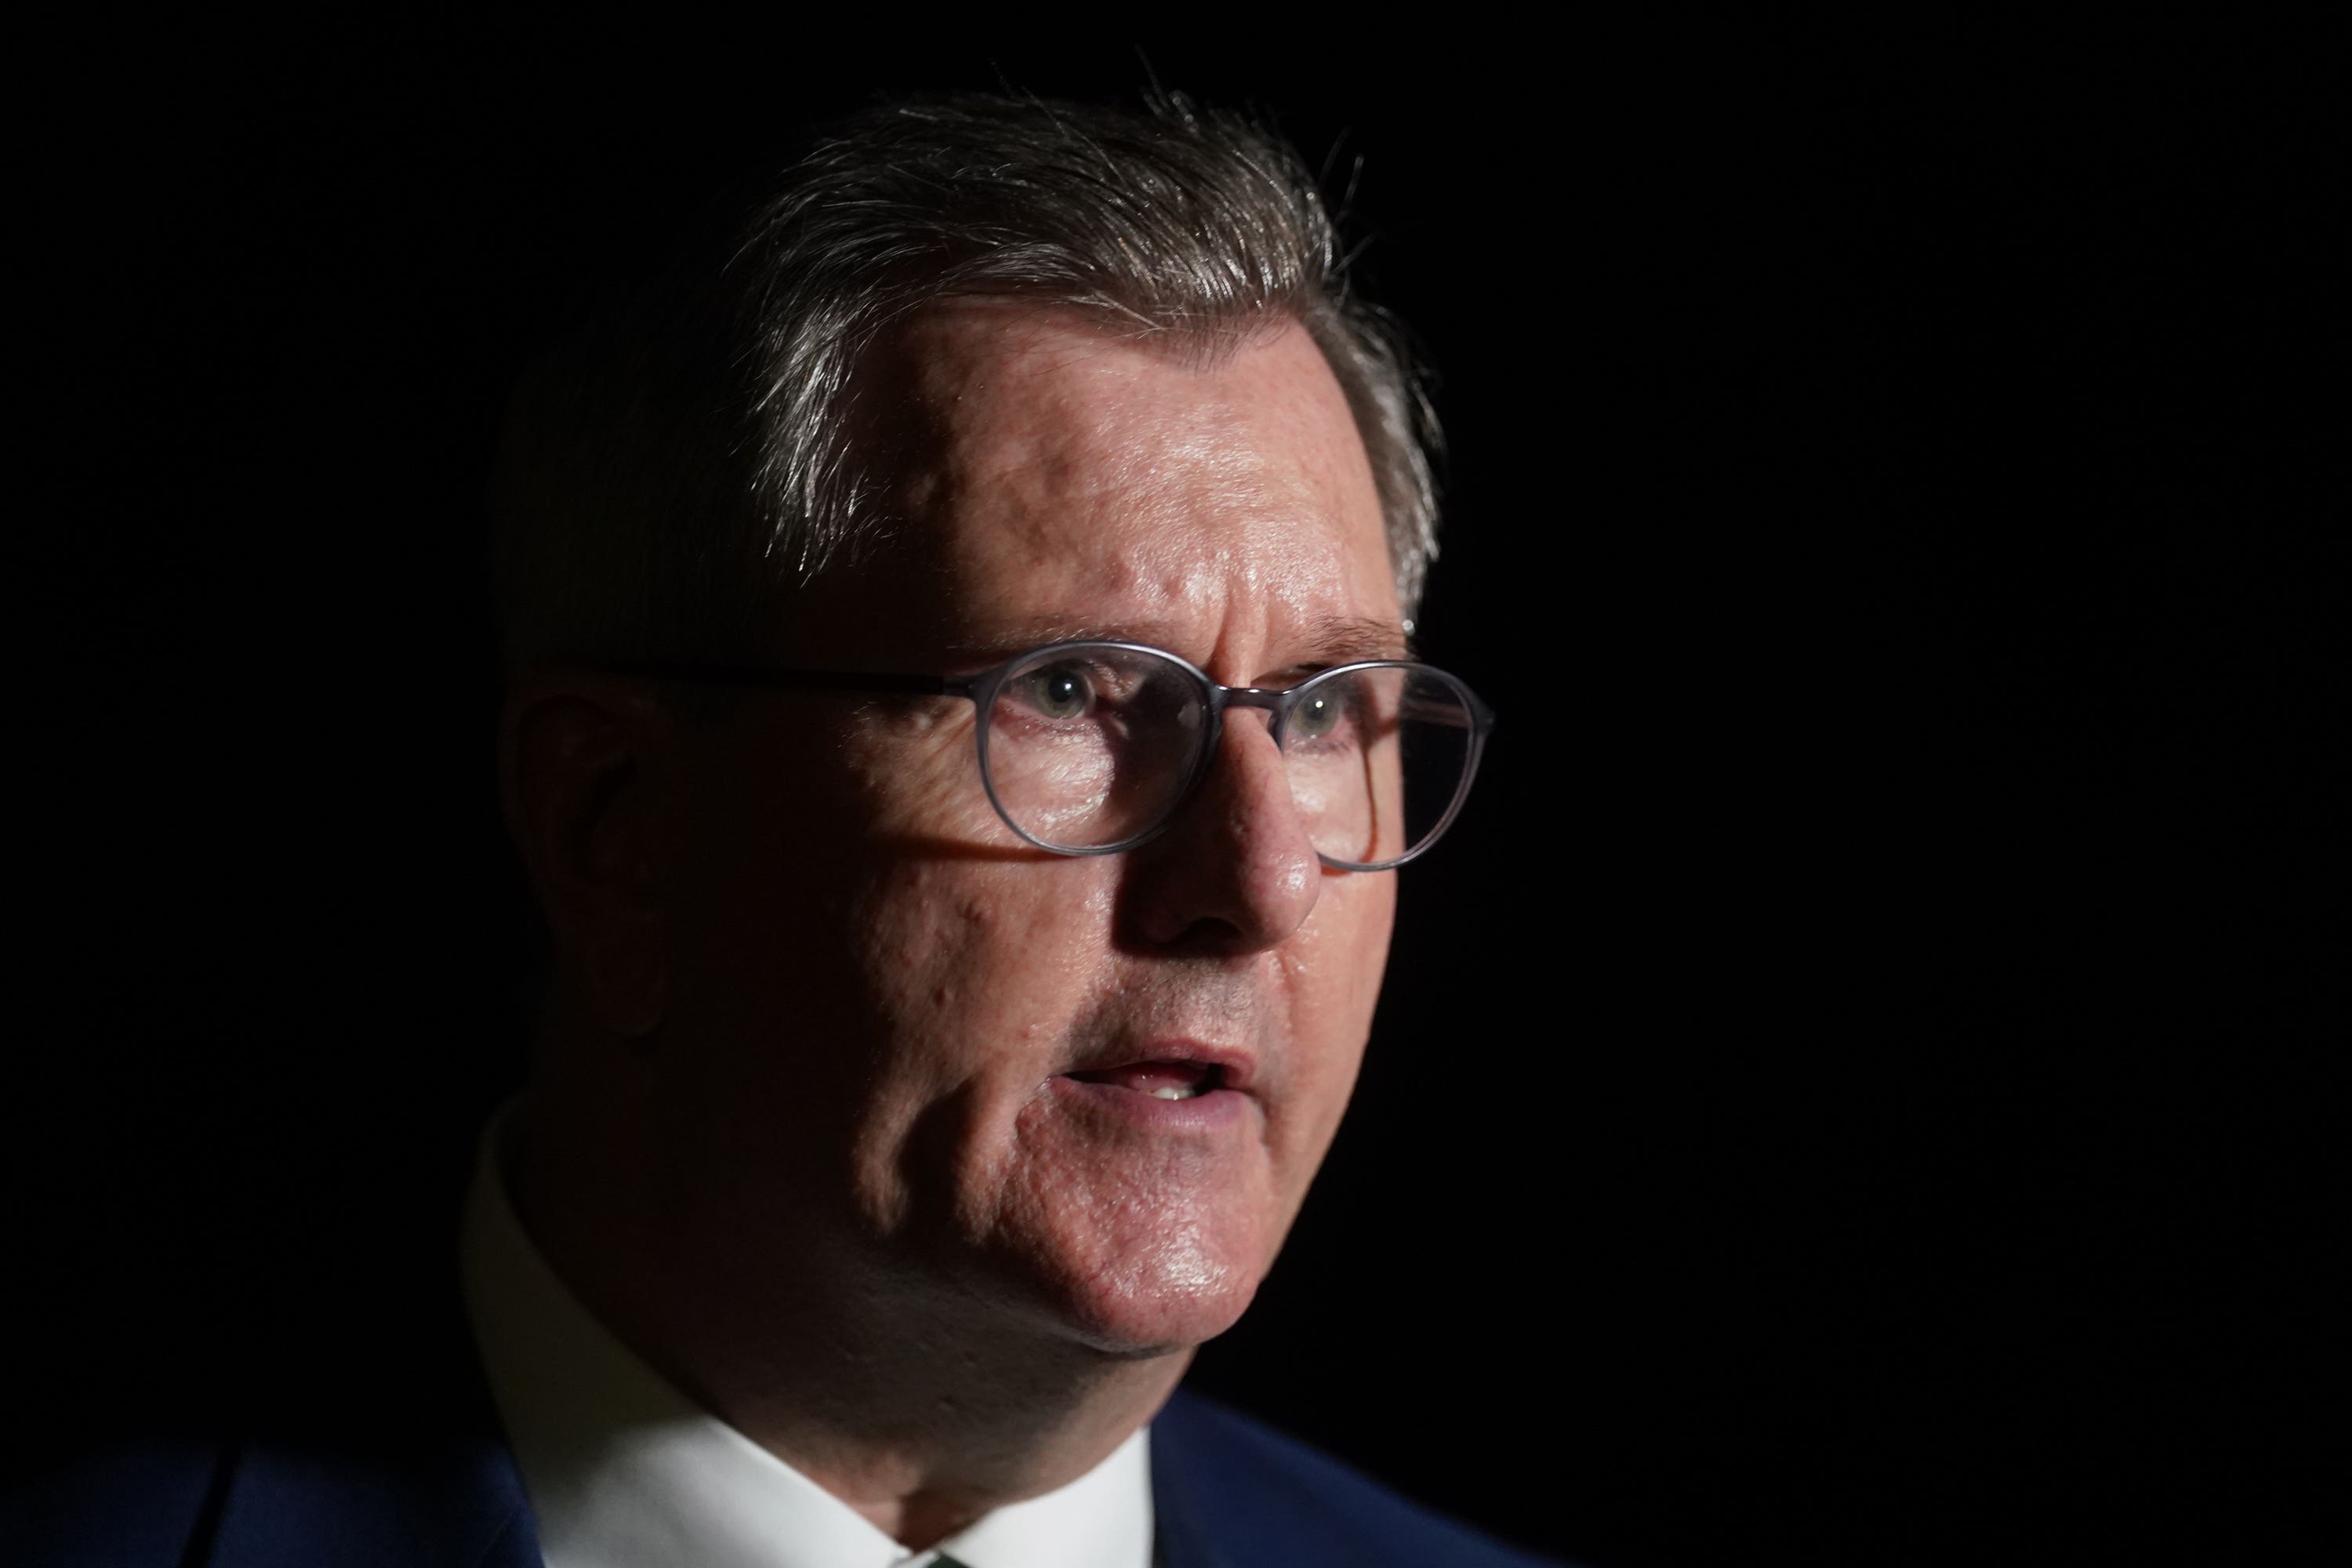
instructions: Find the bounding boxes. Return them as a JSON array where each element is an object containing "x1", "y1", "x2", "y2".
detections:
[{"x1": 510, "y1": 1081, "x2": 1190, "y2": 1549}]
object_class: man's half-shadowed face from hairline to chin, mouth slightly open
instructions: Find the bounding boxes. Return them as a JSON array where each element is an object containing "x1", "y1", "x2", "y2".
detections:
[{"x1": 661, "y1": 301, "x2": 1402, "y2": 1349}]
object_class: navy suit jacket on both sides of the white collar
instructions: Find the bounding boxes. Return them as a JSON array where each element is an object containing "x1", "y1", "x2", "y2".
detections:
[{"x1": 23, "y1": 1389, "x2": 1538, "y2": 1568}]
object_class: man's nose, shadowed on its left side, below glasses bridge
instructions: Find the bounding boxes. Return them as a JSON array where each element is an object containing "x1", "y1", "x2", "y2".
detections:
[{"x1": 1122, "y1": 710, "x2": 1322, "y2": 954}]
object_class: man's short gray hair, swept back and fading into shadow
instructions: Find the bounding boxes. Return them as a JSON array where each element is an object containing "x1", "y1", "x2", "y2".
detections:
[{"x1": 496, "y1": 94, "x2": 1439, "y2": 663}]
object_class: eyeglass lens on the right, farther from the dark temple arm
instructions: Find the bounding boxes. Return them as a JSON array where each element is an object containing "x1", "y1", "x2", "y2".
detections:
[{"x1": 1282, "y1": 666, "x2": 1475, "y2": 867}]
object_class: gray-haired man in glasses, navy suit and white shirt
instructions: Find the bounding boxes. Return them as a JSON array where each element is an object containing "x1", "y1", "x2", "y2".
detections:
[{"x1": 18, "y1": 99, "x2": 1524, "y2": 1568}]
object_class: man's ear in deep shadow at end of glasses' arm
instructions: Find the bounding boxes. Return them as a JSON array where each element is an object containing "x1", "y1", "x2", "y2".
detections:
[{"x1": 499, "y1": 670, "x2": 684, "y2": 1039}]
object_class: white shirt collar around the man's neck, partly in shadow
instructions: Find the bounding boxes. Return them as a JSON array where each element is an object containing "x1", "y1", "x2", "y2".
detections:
[{"x1": 463, "y1": 1112, "x2": 1152, "y2": 1568}]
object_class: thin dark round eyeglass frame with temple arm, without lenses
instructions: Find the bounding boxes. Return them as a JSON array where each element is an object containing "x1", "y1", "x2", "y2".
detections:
[{"x1": 619, "y1": 637, "x2": 1494, "y2": 872}]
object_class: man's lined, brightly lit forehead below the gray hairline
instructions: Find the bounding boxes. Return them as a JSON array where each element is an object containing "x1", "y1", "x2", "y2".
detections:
[{"x1": 809, "y1": 301, "x2": 1402, "y2": 680}]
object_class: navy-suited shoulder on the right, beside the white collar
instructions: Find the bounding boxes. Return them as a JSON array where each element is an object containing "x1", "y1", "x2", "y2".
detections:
[{"x1": 1152, "y1": 1392, "x2": 1545, "y2": 1568}]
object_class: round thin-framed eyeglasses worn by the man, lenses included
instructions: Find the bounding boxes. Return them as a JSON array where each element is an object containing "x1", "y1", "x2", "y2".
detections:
[{"x1": 633, "y1": 640, "x2": 1494, "y2": 872}]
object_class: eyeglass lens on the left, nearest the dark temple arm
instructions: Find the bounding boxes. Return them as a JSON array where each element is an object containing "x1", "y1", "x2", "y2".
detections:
[{"x1": 988, "y1": 647, "x2": 1207, "y2": 848}]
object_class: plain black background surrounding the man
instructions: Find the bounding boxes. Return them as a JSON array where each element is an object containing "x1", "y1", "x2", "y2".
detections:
[{"x1": 9, "y1": 19, "x2": 2347, "y2": 1566}]
